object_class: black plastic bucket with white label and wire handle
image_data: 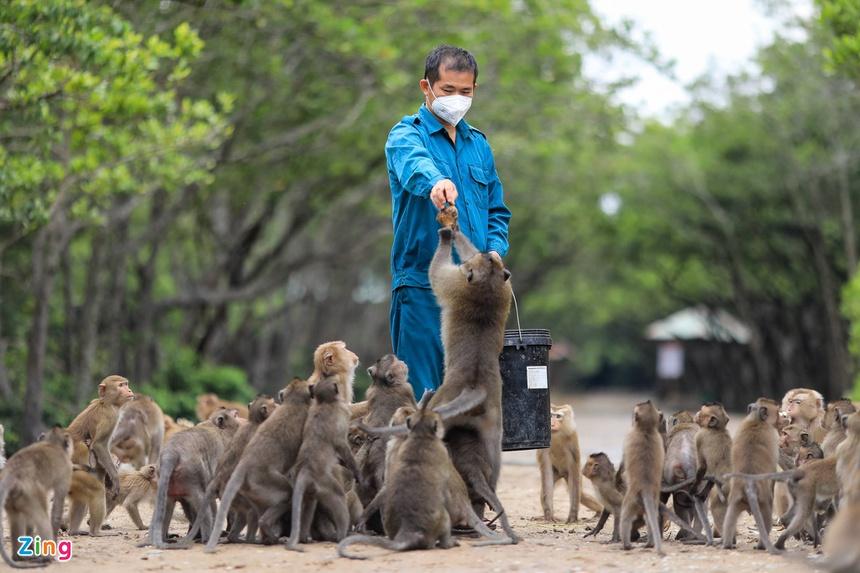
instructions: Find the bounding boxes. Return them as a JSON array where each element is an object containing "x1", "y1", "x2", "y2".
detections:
[{"x1": 499, "y1": 328, "x2": 552, "y2": 451}]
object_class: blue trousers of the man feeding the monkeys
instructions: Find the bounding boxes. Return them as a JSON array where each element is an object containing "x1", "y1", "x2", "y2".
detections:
[{"x1": 389, "y1": 286, "x2": 445, "y2": 399}]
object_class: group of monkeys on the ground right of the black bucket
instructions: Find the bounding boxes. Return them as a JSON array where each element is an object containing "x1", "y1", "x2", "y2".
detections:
[{"x1": 537, "y1": 388, "x2": 860, "y2": 572}]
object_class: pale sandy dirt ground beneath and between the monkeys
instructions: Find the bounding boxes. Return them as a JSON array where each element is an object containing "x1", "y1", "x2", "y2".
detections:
[{"x1": 20, "y1": 394, "x2": 828, "y2": 573}]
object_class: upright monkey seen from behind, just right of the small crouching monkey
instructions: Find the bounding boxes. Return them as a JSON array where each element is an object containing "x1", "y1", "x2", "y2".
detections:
[{"x1": 620, "y1": 400, "x2": 665, "y2": 555}]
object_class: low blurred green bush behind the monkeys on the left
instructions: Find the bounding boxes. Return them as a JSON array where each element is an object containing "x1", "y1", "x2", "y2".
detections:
[{"x1": 146, "y1": 349, "x2": 256, "y2": 420}]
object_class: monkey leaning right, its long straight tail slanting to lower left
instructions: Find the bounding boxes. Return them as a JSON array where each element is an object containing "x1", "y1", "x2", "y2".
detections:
[{"x1": 205, "y1": 378, "x2": 311, "y2": 552}]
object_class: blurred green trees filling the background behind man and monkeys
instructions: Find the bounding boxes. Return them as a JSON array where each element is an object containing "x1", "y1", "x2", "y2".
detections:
[{"x1": 0, "y1": 0, "x2": 860, "y2": 444}]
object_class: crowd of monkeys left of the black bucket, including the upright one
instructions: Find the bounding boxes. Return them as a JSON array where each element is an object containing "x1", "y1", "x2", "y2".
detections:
[{"x1": 0, "y1": 207, "x2": 519, "y2": 568}]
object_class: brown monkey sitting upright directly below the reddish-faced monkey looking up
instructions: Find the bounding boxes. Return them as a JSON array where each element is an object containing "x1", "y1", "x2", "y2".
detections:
[{"x1": 287, "y1": 378, "x2": 362, "y2": 549}]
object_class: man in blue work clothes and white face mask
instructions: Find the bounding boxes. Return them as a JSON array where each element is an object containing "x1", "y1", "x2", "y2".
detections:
[{"x1": 385, "y1": 46, "x2": 511, "y2": 396}]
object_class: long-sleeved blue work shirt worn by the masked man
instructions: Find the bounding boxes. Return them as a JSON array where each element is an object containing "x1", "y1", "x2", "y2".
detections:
[{"x1": 385, "y1": 105, "x2": 511, "y2": 290}]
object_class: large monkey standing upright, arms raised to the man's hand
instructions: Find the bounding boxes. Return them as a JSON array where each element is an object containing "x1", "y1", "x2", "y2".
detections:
[{"x1": 429, "y1": 222, "x2": 518, "y2": 540}]
